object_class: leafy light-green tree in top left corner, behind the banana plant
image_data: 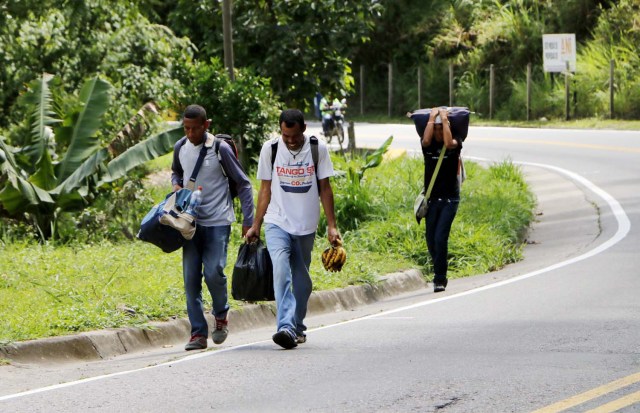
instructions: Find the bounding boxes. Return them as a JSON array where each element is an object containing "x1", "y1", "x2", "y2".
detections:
[{"x1": 0, "y1": 0, "x2": 193, "y2": 132}]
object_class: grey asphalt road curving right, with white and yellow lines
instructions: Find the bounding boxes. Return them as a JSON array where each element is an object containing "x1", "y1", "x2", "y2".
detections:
[{"x1": 0, "y1": 120, "x2": 640, "y2": 412}]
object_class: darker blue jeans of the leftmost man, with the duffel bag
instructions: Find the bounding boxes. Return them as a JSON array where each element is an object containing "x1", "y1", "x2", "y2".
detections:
[{"x1": 182, "y1": 225, "x2": 231, "y2": 337}]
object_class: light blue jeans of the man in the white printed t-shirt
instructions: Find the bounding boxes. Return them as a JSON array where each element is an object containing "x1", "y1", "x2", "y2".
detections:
[{"x1": 264, "y1": 224, "x2": 316, "y2": 335}]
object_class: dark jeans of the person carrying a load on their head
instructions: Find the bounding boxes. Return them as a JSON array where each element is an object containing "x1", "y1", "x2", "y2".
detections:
[{"x1": 426, "y1": 198, "x2": 460, "y2": 285}]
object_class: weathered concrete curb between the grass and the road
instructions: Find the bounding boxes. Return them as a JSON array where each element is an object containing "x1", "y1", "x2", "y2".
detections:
[{"x1": 0, "y1": 270, "x2": 427, "y2": 363}]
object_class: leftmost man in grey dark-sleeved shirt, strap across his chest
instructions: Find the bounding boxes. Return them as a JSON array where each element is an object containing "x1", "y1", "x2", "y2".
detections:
[{"x1": 171, "y1": 105, "x2": 254, "y2": 350}]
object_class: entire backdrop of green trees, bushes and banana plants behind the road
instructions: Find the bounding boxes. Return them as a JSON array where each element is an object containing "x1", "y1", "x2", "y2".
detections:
[{"x1": 0, "y1": 0, "x2": 640, "y2": 239}]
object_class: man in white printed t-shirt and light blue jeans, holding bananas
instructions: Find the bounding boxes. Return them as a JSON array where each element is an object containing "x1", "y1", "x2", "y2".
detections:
[{"x1": 246, "y1": 109, "x2": 340, "y2": 349}]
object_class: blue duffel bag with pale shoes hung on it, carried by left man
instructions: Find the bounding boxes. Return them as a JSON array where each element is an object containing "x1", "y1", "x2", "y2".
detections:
[{"x1": 137, "y1": 188, "x2": 196, "y2": 253}]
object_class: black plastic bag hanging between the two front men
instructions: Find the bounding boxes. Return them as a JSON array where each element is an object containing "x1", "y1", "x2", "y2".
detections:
[{"x1": 231, "y1": 240, "x2": 275, "y2": 301}]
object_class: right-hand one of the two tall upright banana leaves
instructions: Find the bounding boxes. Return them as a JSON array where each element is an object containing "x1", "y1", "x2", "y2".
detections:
[{"x1": 58, "y1": 77, "x2": 111, "y2": 183}]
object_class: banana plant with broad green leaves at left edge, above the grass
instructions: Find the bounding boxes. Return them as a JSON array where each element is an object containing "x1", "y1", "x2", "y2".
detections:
[{"x1": 0, "y1": 74, "x2": 183, "y2": 240}]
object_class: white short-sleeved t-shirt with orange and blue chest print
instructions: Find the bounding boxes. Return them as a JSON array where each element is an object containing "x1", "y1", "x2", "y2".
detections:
[{"x1": 258, "y1": 136, "x2": 333, "y2": 235}]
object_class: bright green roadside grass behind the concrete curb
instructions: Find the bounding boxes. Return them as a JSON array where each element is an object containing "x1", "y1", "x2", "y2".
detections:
[{"x1": 0, "y1": 157, "x2": 534, "y2": 344}]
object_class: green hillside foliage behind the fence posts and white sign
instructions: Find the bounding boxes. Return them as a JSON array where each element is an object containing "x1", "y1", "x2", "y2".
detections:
[{"x1": 353, "y1": 0, "x2": 640, "y2": 119}]
